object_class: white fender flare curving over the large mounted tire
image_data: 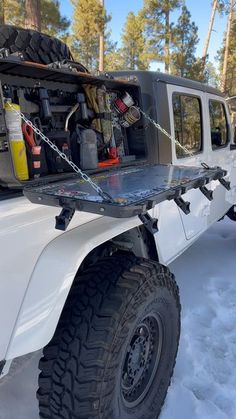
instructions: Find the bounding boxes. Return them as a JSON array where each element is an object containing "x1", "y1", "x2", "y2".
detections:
[{"x1": 5, "y1": 217, "x2": 144, "y2": 360}]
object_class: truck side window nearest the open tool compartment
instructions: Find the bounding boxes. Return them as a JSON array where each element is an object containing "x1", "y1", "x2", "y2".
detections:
[{"x1": 173, "y1": 93, "x2": 202, "y2": 158}]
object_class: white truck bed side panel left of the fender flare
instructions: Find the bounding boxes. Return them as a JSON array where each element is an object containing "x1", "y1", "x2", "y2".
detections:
[{"x1": 0, "y1": 197, "x2": 101, "y2": 359}]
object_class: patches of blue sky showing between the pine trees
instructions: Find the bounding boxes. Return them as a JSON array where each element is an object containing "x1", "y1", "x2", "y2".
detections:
[{"x1": 60, "y1": 0, "x2": 226, "y2": 67}]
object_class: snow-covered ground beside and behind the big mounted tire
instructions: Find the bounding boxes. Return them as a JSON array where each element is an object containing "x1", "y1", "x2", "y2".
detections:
[{"x1": 0, "y1": 221, "x2": 236, "y2": 419}]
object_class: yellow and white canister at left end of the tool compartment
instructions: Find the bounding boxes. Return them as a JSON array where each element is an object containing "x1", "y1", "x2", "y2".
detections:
[{"x1": 5, "y1": 102, "x2": 29, "y2": 180}]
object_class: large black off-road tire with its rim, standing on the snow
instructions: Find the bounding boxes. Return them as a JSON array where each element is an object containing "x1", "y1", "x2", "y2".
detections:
[{"x1": 37, "y1": 255, "x2": 180, "y2": 419}]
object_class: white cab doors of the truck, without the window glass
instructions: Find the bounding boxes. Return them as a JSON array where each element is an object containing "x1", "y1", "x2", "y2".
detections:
[{"x1": 168, "y1": 85, "x2": 236, "y2": 240}]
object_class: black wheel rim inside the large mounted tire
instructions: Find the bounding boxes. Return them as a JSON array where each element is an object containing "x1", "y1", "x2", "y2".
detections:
[{"x1": 121, "y1": 313, "x2": 163, "y2": 408}]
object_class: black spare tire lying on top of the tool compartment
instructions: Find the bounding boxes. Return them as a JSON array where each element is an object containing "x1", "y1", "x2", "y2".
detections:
[{"x1": 0, "y1": 25, "x2": 72, "y2": 64}]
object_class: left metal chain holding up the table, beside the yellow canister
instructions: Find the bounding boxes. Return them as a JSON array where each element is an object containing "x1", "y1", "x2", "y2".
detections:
[{"x1": 8, "y1": 102, "x2": 113, "y2": 202}]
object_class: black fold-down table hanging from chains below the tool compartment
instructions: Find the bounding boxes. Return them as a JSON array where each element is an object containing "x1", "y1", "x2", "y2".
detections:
[{"x1": 24, "y1": 165, "x2": 230, "y2": 230}]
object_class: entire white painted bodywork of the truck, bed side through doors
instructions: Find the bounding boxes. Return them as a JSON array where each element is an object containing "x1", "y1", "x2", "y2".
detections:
[{"x1": 0, "y1": 86, "x2": 236, "y2": 370}]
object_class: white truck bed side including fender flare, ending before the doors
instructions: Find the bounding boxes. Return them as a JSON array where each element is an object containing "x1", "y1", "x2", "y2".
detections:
[{"x1": 0, "y1": 197, "x2": 189, "y2": 360}]
